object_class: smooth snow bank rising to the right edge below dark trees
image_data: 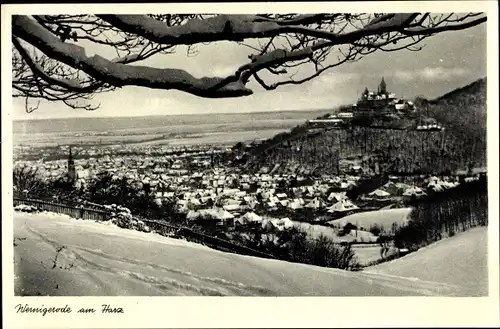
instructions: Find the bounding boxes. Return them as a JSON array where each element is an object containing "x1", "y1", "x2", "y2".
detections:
[{"x1": 365, "y1": 227, "x2": 488, "y2": 296}]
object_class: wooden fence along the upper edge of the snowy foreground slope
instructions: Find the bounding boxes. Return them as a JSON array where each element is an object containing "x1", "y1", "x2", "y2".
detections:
[{"x1": 14, "y1": 198, "x2": 275, "y2": 258}]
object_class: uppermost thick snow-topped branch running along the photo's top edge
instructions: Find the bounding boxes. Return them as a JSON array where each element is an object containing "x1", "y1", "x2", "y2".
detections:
[{"x1": 97, "y1": 13, "x2": 486, "y2": 45}]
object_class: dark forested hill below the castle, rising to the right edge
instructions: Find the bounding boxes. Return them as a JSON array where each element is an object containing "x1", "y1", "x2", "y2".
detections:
[{"x1": 241, "y1": 78, "x2": 486, "y2": 174}]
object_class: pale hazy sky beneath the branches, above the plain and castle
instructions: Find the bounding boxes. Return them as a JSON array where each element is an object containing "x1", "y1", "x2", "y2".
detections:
[{"x1": 13, "y1": 16, "x2": 486, "y2": 119}]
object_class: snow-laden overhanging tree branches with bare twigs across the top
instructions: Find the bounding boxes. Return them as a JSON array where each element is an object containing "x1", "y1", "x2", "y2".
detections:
[{"x1": 12, "y1": 13, "x2": 487, "y2": 109}]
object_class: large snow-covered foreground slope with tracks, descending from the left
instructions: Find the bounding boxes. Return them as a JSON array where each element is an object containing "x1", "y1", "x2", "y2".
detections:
[{"x1": 14, "y1": 213, "x2": 484, "y2": 296}]
